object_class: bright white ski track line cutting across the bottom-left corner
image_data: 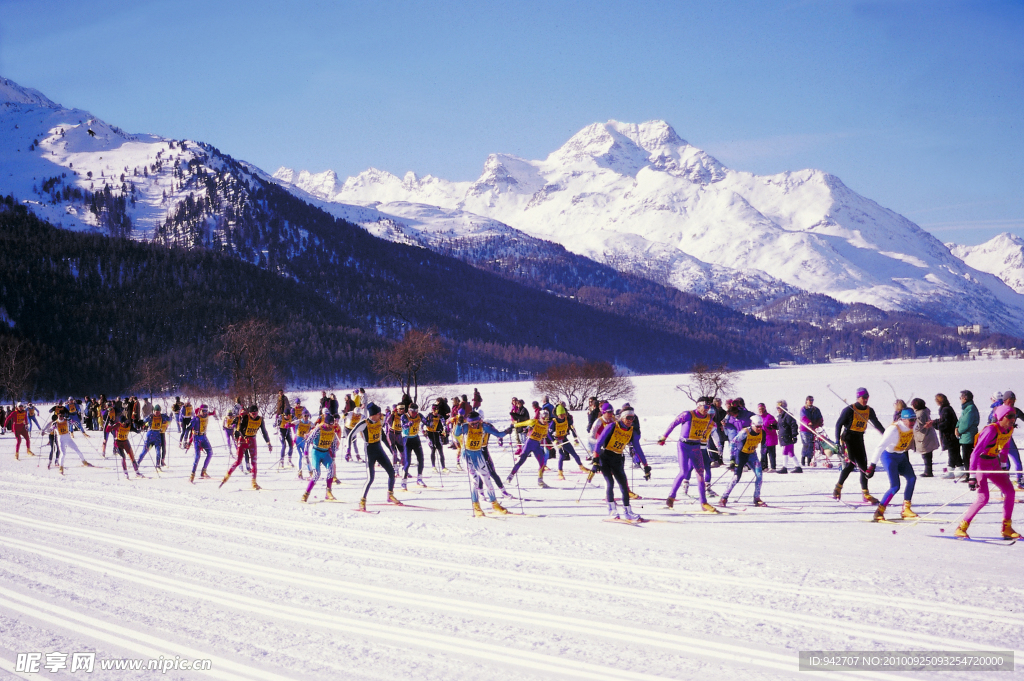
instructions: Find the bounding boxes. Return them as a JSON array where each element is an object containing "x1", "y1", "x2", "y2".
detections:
[{"x1": 0, "y1": 587, "x2": 291, "y2": 681}]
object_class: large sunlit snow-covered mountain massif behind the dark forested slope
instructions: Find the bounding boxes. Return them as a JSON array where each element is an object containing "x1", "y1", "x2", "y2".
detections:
[{"x1": 275, "y1": 121, "x2": 1024, "y2": 334}]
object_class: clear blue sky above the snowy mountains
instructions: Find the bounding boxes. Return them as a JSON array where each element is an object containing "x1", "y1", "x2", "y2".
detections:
[{"x1": 0, "y1": 0, "x2": 1024, "y2": 244}]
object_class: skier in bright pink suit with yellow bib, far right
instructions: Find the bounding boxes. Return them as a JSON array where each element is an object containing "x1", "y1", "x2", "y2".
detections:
[{"x1": 954, "y1": 405, "x2": 1020, "y2": 539}]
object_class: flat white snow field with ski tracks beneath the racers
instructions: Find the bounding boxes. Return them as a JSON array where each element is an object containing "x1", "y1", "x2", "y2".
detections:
[{"x1": 0, "y1": 360, "x2": 1024, "y2": 681}]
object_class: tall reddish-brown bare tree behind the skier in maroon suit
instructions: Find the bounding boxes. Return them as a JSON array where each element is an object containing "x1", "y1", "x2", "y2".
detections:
[{"x1": 218, "y1": 318, "x2": 284, "y2": 414}]
